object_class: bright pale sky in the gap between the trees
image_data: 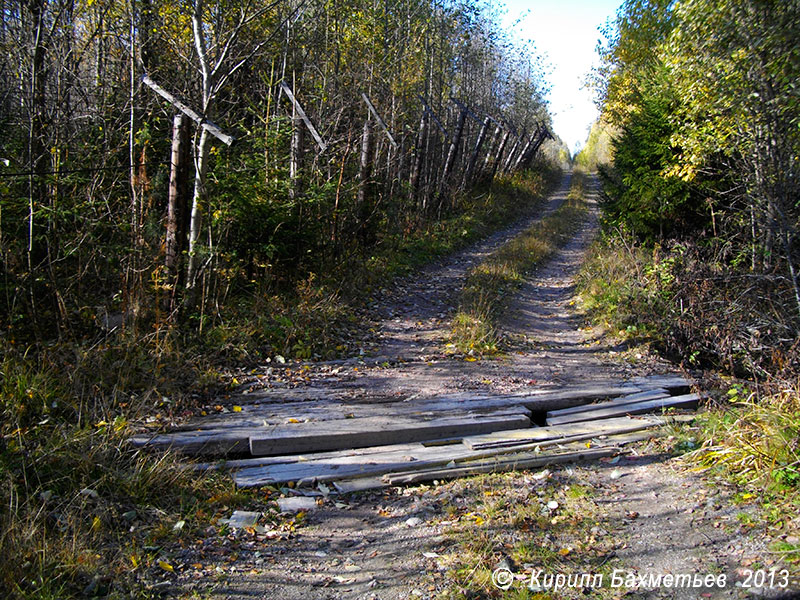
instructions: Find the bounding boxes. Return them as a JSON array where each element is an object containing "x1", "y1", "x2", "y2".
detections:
[{"x1": 496, "y1": 0, "x2": 622, "y2": 152}]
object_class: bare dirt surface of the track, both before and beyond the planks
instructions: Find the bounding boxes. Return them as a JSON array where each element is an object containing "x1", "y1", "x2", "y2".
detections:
[{"x1": 198, "y1": 173, "x2": 780, "y2": 600}]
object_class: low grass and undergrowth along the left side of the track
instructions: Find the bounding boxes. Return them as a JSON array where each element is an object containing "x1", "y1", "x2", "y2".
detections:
[{"x1": 0, "y1": 165, "x2": 560, "y2": 599}]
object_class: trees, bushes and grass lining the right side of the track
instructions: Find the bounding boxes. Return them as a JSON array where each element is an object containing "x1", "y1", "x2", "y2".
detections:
[{"x1": 577, "y1": 0, "x2": 800, "y2": 561}]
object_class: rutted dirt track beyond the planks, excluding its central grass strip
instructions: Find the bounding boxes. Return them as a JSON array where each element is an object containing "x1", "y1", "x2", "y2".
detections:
[{"x1": 240, "y1": 174, "x2": 638, "y2": 402}]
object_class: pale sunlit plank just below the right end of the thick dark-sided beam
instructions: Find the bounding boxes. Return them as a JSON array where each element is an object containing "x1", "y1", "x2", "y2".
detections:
[{"x1": 463, "y1": 417, "x2": 664, "y2": 450}]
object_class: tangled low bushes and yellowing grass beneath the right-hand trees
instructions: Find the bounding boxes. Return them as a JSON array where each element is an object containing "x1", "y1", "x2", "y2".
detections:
[{"x1": 579, "y1": 229, "x2": 800, "y2": 561}]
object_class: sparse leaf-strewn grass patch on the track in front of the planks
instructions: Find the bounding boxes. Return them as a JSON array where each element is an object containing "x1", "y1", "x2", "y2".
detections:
[{"x1": 439, "y1": 470, "x2": 615, "y2": 600}]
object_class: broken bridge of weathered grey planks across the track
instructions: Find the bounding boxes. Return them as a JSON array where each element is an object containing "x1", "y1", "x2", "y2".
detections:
[{"x1": 131, "y1": 375, "x2": 703, "y2": 493}]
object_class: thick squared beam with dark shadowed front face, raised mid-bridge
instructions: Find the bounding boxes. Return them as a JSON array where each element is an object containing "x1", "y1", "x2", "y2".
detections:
[{"x1": 250, "y1": 415, "x2": 530, "y2": 456}]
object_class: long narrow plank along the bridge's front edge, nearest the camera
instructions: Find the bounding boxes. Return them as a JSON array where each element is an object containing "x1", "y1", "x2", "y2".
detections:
[{"x1": 384, "y1": 448, "x2": 620, "y2": 485}]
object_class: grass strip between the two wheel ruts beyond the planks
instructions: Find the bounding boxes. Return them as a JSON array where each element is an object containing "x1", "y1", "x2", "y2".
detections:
[{"x1": 452, "y1": 172, "x2": 587, "y2": 356}]
